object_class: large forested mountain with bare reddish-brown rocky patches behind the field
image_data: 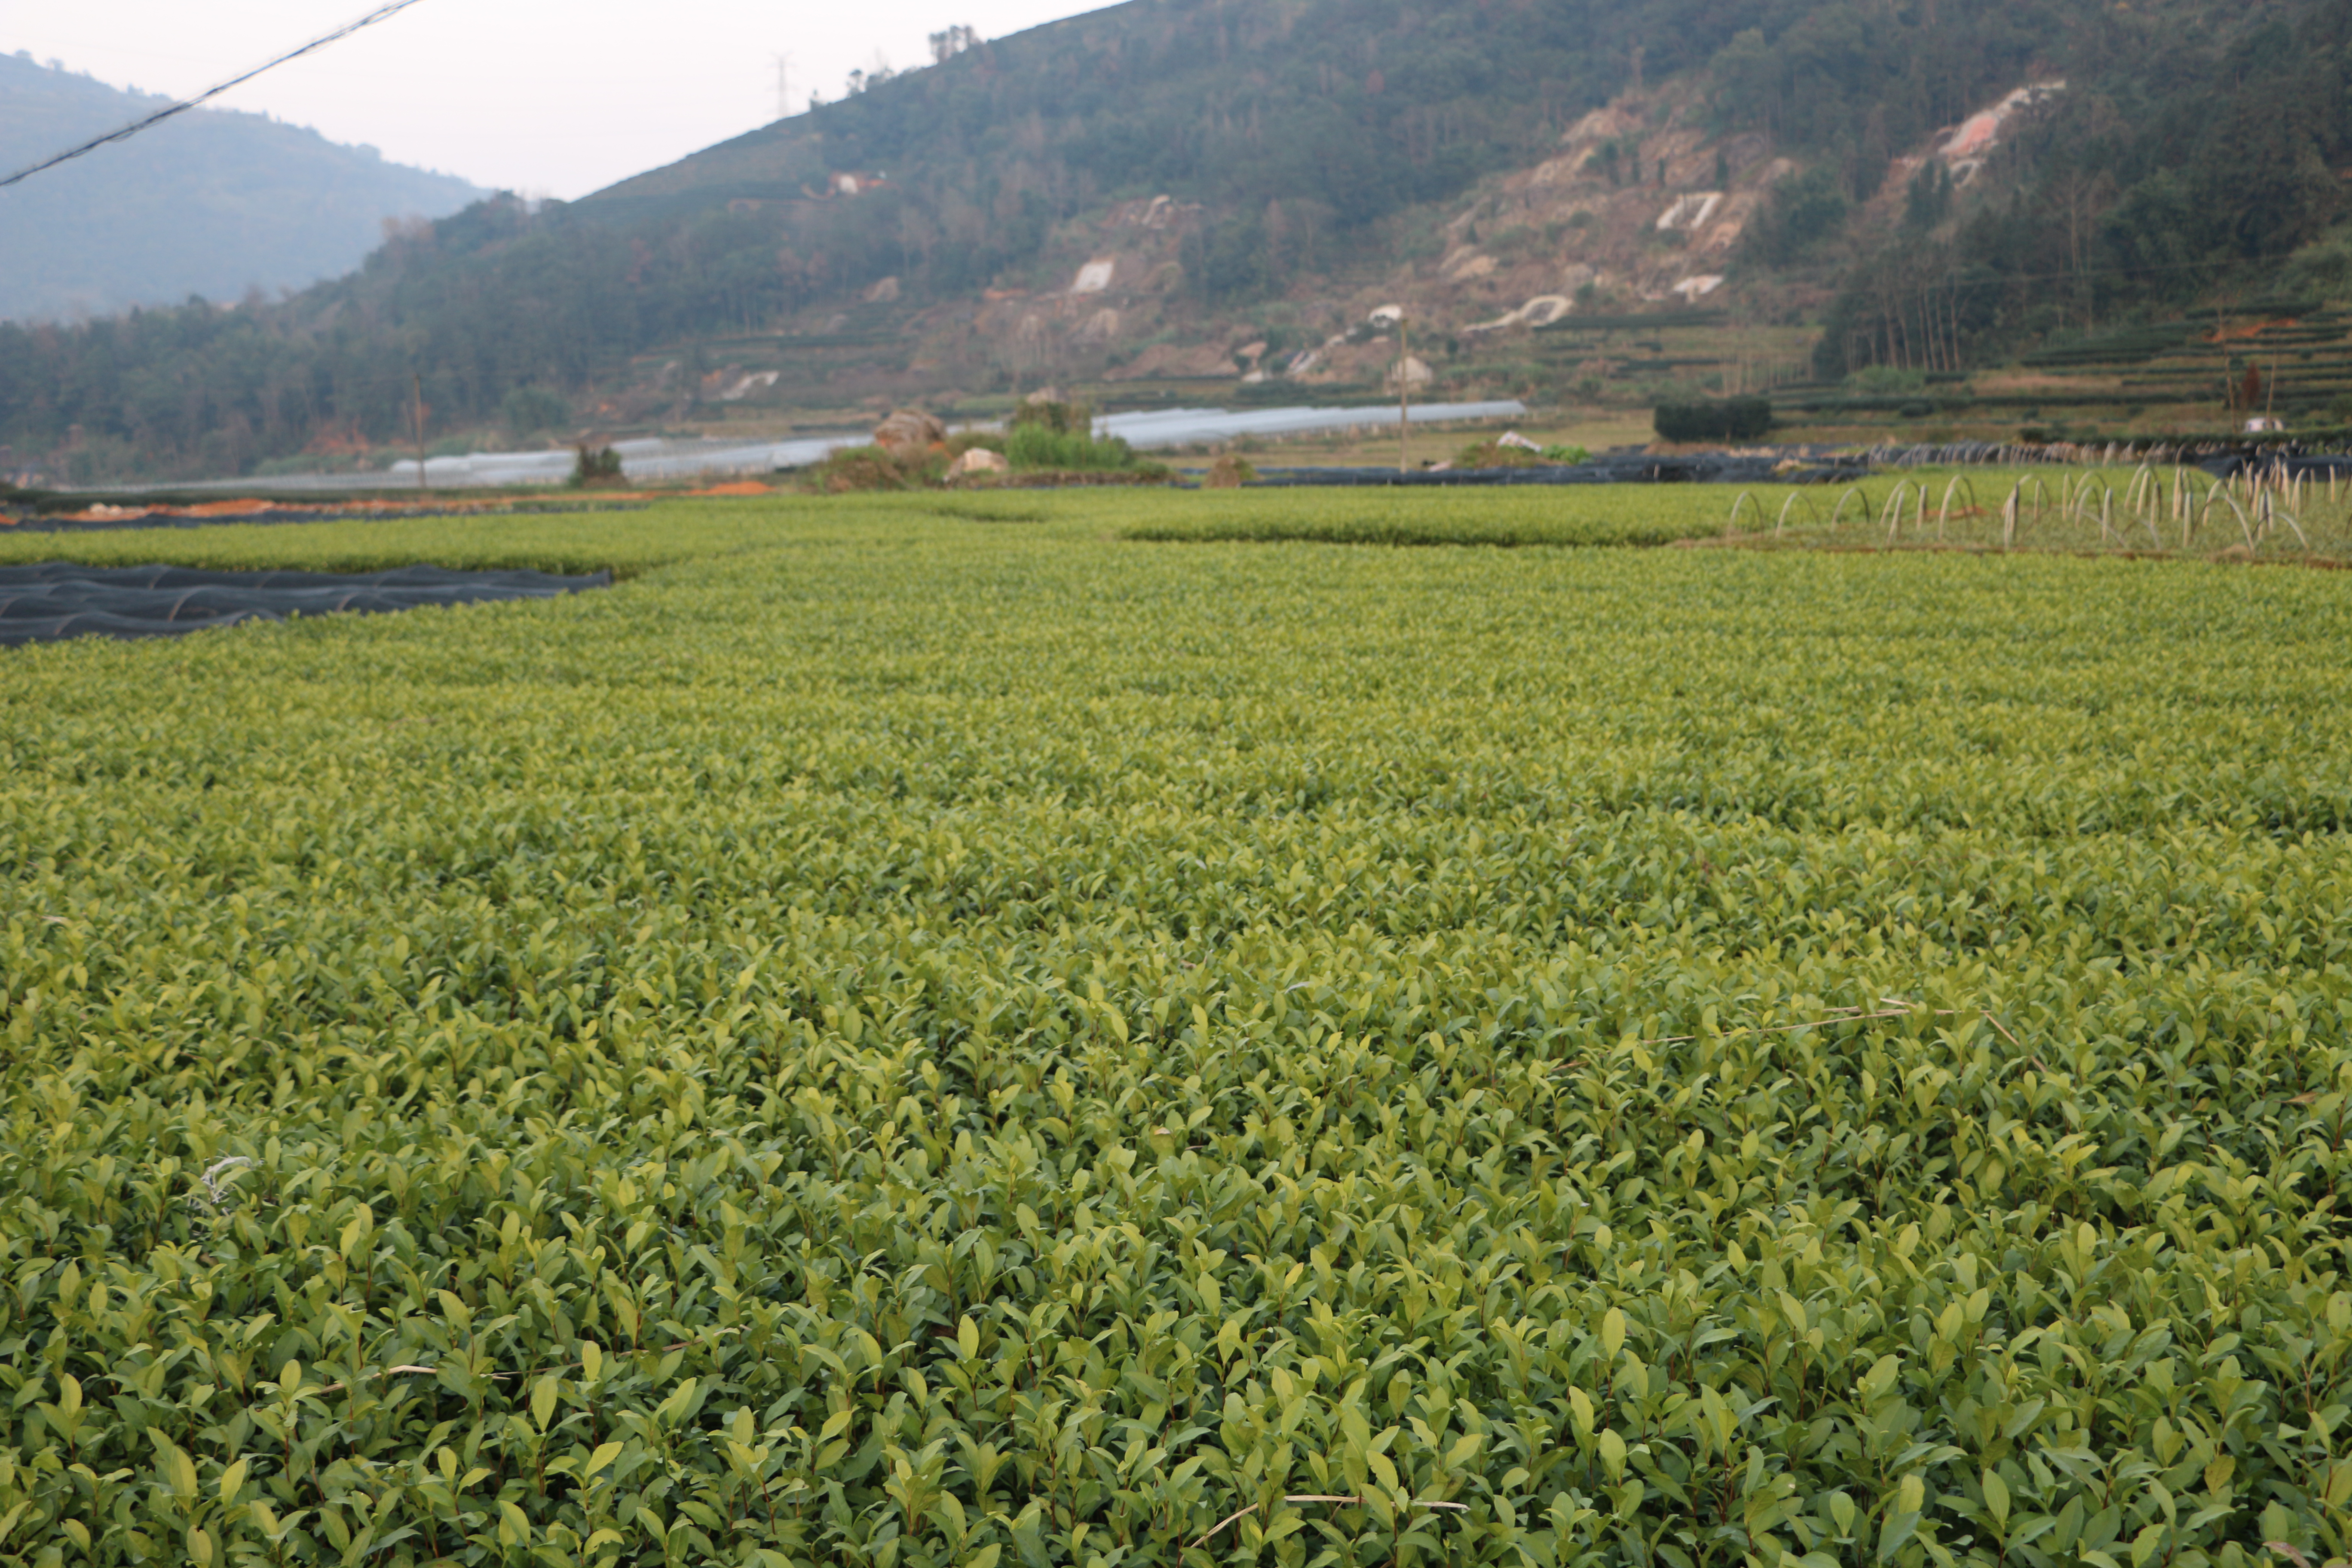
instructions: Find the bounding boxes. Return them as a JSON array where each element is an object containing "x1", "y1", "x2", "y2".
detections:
[{"x1": 0, "y1": 0, "x2": 2352, "y2": 472}]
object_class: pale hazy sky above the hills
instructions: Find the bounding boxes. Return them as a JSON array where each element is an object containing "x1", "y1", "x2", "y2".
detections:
[{"x1": 0, "y1": 0, "x2": 1096, "y2": 200}]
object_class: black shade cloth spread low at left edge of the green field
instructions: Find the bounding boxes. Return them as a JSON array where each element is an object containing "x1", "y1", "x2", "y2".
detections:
[{"x1": 0, "y1": 562, "x2": 612, "y2": 646}]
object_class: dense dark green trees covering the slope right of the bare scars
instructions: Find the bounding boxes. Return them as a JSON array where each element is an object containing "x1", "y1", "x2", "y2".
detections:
[{"x1": 1780, "y1": 2, "x2": 2352, "y2": 376}]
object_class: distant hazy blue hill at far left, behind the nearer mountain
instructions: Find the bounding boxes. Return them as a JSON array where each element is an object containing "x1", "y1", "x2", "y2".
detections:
[{"x1": 0, "y1": 54, "x2": 482, "y2": 322}]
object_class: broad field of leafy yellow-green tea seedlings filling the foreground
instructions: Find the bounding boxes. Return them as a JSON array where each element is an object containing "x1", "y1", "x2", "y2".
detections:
[{"x1": 0, "y1": 496, "x2": 2352, "y2": 1568}]
